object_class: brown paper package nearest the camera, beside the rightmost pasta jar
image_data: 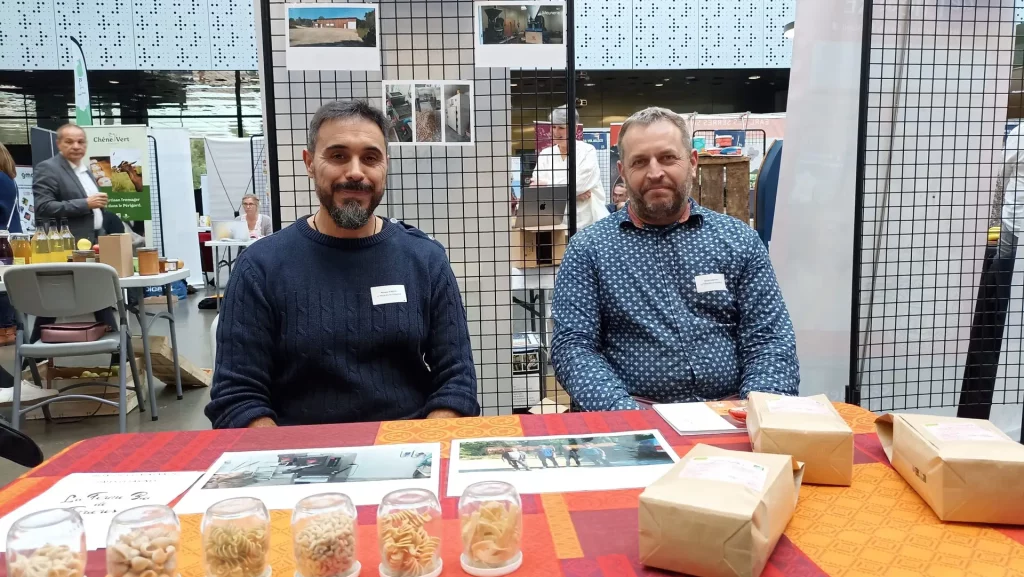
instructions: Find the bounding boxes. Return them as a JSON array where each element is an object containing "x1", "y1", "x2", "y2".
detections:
[{"x1": 639, "y1": 444, "x2": 804, "y2": 577}]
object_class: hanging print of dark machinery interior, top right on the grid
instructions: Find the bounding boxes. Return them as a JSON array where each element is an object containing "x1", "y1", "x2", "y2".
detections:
[{"x1": 474, "y1": 1, "x2": 565, "y2": 69}]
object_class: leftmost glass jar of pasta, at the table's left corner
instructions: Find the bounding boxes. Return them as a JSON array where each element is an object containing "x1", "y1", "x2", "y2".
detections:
[{"x1": 6, "y1": 509, "x2": 87, "y2": 577}]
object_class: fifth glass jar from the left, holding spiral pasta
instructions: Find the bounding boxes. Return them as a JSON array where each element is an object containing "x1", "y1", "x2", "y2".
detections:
[{"x1": 377, "y1": 489, "x2": 441, "y2": 577}]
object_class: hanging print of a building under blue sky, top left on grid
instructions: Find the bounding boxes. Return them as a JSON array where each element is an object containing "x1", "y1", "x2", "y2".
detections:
[{"x1": 285, "y1": 4, "x2": 381, "y2": 71}]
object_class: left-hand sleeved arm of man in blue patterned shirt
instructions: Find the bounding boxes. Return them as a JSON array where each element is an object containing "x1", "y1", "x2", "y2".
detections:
[{"x1": 551, "y1": 242, "x2": 639, "y2": 411}]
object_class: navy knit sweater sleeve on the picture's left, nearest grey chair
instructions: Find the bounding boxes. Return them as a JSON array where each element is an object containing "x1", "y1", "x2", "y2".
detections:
[{"x1": 206, "y1": 253, "x2": 278, "y2": 428}]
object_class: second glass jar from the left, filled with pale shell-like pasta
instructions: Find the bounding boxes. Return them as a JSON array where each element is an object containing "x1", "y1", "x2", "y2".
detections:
[{"x1": 106, "y1": 505, "x2": 181, "y2": 577}]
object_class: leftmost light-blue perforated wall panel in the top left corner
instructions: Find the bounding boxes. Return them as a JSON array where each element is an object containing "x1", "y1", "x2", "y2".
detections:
[{"x1": 0, "y1": 0, "x2": 57, "y2": 69}]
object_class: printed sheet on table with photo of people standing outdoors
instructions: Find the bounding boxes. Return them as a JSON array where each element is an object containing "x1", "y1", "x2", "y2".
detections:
[{"x1": 447, "y1": 429, "x2": 679, "y2": 497}]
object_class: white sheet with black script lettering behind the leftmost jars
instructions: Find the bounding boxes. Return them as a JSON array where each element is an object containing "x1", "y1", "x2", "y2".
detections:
[{"x1": 0, "y1": 471, "x2": 203, "y2": 550}]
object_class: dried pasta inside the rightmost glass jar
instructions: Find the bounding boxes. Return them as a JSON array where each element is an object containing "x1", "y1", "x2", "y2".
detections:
[{"x1": 462, "y1": 501, "x2": 522, "y2": 569}]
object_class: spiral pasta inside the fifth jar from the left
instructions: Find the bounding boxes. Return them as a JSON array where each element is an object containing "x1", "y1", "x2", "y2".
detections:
[{"x1": 377, "y1": 510, "x2": 441, "y2": 577}]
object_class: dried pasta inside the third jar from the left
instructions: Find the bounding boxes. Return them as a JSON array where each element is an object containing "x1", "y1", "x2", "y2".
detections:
[{"x1": 203, "y1": 525, "x2": 270, "y2": 577}]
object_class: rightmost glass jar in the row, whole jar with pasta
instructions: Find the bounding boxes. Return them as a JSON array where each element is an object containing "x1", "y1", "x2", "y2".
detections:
[{"x1": 459, "y1": 481, "x2": 522, "y2": 577}]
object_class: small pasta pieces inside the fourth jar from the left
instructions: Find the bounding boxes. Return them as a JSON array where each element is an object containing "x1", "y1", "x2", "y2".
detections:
[{"x1": 294, "y1": 512, "x2": 355, "y2": 577}]
